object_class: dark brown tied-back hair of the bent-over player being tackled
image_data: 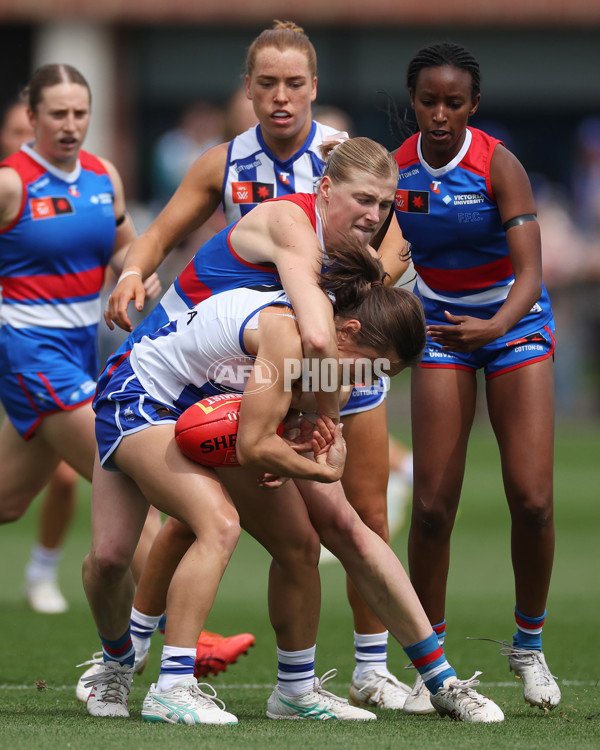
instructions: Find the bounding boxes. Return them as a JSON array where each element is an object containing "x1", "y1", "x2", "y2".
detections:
[{"x1": 320, "y1": 242, "x2": 425, "y2": 366}]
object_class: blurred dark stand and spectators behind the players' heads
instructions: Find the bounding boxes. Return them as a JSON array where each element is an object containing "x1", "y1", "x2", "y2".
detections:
[{"x1": 0, "y1": 0, "x2": 600, "y2": 417}]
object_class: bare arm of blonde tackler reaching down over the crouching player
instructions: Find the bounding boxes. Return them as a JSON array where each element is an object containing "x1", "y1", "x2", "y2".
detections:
[{"x1": 231, "y1": 201, "x2": 339, "y2": 422}]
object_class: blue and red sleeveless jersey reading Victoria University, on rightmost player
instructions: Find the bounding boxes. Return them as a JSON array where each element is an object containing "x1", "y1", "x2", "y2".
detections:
[{"x1": 395, "y1": 128, "x2": 552, "y2": 328}]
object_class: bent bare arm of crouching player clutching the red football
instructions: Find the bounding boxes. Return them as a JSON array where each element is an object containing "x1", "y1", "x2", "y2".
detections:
[{"x1": 236, "y1": 308, "x2": 346, "y2": 482}]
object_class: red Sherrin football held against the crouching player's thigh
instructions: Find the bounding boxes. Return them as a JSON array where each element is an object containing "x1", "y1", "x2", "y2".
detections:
[{"x1": 175, "y1": 393, "x2": 242, "y2": 466}]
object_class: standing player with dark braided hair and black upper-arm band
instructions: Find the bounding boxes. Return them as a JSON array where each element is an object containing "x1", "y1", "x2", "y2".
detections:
[{"x1": 380, "y1": 44, "x2": 560, "y2": 713}]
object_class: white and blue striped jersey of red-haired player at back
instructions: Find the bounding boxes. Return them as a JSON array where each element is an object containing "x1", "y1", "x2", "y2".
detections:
[{"x1": 222, "y1": 121, "x2": 337, "y2": 224}]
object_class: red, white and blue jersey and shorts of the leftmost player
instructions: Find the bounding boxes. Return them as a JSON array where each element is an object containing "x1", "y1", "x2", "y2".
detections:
[{"x1": 0, "y1": 145, "x2": 116, "y2": 436}]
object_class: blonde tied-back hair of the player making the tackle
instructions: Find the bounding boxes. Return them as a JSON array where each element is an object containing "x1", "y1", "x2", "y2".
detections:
[{"x1": 320, "y1": 137, "x2": 398, "y2": 189}]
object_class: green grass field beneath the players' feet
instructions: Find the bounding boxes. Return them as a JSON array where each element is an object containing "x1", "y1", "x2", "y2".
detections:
[{"x1": 0, "y1": 408, "x2": 600, "y2": 750}]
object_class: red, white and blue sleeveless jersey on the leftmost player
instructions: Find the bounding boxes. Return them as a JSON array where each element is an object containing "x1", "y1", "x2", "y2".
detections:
[{"x1": 0, "y1": 145, "x2": 116, "y2": 338}]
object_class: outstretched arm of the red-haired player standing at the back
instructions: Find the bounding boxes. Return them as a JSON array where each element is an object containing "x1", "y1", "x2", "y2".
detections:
[{"x1": 105, "y1": 143, "x2": 227, "y2": 331}]
